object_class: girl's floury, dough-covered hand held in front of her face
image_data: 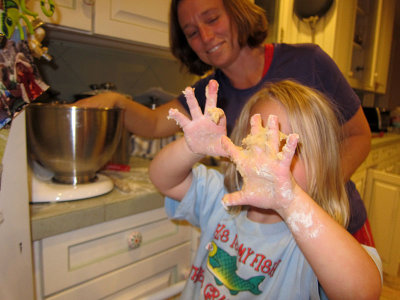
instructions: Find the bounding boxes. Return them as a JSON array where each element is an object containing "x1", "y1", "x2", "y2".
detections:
[{"x1": 222, "y1": 114, "x2": 298, "y2": 211}]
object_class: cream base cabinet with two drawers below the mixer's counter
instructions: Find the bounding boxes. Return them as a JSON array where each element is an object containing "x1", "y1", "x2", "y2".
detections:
[{"x1": 34, "y1": 208, "x2": 191, "y2": 299}]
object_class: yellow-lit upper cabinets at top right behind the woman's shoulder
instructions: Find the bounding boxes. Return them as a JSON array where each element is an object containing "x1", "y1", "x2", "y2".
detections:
[{"x1": 278, "y1": 0, "x2": 395, "y2": 93}]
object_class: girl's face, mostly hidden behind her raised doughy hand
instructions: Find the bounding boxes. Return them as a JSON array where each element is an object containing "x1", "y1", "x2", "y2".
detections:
[{"x1": 250, "y1": 100, "x2": 307, "y2": 191}]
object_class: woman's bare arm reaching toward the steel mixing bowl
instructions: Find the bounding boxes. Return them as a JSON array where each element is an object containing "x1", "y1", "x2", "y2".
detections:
[{"x1": 74, "y1": 92, "x2": 189, "y2": 138}]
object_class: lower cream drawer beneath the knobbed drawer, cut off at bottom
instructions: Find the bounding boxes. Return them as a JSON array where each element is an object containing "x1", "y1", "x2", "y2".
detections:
[{"x1": 46, "y1": 242, "x2": 190, "y2": 300}]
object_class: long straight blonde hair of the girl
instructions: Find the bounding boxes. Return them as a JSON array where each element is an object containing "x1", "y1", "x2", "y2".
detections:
[{"x1": 225, "y1": 80, "x2": 350, "y2": 226}]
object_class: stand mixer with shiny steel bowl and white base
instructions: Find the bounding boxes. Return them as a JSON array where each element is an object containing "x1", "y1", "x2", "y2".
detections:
[{"x1": 26, "y1": 103, "x2": 123, "y2": 202}]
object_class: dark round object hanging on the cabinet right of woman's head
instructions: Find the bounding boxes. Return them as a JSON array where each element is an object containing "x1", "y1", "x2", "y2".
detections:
[{"x1": 293, "y1": 0, "x2": 333, "y2": 43}]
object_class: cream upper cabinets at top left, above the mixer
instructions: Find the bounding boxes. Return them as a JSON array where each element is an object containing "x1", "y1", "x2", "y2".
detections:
[{"x1": 24, "y1": 0, "x2": 170, "y2": 48}]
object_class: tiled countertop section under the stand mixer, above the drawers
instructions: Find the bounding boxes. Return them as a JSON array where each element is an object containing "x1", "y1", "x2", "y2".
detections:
[{"x1": 30, "y1": 157, "x2": 164, "y2": 241}]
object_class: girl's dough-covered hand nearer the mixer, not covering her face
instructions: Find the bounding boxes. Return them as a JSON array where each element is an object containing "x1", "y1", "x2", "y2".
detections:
[{"x1": 168, "y1": 80, "x2": 226, "y2": 156}]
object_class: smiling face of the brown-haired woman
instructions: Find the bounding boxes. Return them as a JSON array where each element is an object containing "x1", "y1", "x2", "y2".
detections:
[{"x1": 178, "y1": 0, "x2": 240, "y2": 69}]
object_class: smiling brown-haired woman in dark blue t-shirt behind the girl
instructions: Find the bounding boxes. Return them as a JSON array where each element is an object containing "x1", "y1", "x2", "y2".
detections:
[{"x1": 79, "y1": 0, "x2": 373, "y2": 240}]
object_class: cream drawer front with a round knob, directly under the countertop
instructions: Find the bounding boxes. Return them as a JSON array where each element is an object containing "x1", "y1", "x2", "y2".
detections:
[{"x1": 36, "y1": 208, "x2": 191, "y2": 295}]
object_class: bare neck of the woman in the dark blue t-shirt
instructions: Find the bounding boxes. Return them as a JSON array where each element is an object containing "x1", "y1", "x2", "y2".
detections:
[{"x1": 221, "y1": 45, "x2": 265, "y2": 89}]
